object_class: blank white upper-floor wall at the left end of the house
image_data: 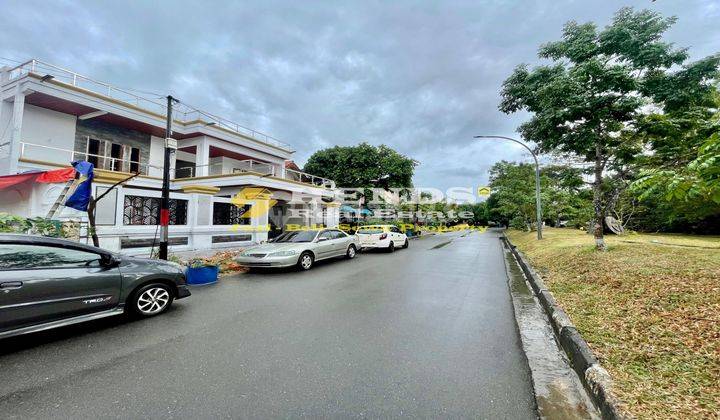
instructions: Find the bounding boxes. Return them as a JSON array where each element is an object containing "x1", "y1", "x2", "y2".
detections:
[{"x1": 22, "y1": 104, "x2": 77, "y2": 165}]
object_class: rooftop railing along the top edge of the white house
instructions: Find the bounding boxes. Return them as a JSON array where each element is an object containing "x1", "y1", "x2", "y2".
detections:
[{"x1": 9, "y1": 60, "x2": 293, "y2": 151}]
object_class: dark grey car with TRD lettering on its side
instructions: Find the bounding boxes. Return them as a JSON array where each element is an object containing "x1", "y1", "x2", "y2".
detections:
[{"x1": 0, "y1": 234, "x2": 190, "y2": 338}]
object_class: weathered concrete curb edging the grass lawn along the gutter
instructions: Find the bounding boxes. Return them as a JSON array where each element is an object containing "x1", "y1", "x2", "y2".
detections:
[{"x1": 500, "y1": 234, "x2": 626, "y2": 419}]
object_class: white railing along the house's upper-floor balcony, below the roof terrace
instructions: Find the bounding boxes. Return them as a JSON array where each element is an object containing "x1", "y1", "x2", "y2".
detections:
[{"x1": 20, "y1": 142, "x2": 335, "y2": 189}]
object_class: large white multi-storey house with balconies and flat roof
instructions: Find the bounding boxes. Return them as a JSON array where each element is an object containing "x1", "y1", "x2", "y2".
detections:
[{"x1": 0, "y1": 60, "x2": 339, "y2": 254}]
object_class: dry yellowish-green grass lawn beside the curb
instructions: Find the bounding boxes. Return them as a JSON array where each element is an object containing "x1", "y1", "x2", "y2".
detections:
[{"x1": 508, "y1": 228, "x2": 720, "y2": 418}]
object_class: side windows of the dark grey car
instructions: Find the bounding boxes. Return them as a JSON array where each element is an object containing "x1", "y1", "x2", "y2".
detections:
[{"x1": 0, "y1": 244, "x2": 100, "y2": 270}]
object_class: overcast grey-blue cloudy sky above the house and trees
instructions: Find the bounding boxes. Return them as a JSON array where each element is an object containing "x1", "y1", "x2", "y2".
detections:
[{"x1": 0, "y1": 0, "x2": 720, "y2": 189}]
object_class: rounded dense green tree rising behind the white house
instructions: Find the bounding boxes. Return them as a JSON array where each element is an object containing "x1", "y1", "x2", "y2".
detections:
[{"x1": 303, "y1": 143, "x2": 418, "y2": 188}]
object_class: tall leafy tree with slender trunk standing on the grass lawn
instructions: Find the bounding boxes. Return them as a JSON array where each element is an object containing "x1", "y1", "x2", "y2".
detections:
[{"x1": 500, "y1": 8, "x2": 718, "y2": 250}]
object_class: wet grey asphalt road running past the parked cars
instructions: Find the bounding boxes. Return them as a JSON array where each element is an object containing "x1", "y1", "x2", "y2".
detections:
[{"x1": 0, "y1": 232, "x2": 536, "y2": 419}]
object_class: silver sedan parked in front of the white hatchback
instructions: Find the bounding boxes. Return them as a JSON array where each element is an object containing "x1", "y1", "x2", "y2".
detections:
[{"x1": 235, "y1": 229, "x2": 358, "y2": 270}]
